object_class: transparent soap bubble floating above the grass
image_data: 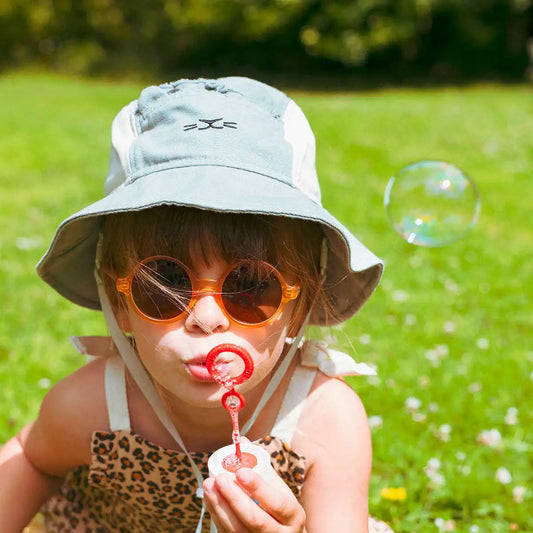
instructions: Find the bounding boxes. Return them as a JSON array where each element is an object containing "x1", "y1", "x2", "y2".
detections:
[{"x1": 384, "y1": 161, "x2": 481, "y2": 247}]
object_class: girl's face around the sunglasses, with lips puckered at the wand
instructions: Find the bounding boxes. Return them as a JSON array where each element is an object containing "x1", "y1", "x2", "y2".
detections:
[{"x1": 120, "y1": 254, "x2": 295, "y2": 407}]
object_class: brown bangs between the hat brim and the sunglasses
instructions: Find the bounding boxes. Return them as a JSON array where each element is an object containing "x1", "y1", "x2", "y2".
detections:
[{"x1": 104, "y1": 206, "x2": 280, "y2": 275}]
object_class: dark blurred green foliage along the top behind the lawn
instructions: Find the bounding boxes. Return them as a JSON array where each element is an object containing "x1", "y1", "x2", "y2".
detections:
[{"x1": 0, "y1": 0, "x2": 533, "y2": 83}]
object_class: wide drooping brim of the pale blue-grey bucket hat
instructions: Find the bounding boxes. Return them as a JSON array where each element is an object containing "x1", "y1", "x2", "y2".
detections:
[{"x1": 37, "y1": 165, "x2": 383, "y2": 324}]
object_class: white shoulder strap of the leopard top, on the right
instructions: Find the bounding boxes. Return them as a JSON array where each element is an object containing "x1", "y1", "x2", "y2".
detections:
[{"x1": 271, "y1": 366, "x2": 316, "y2": 444}]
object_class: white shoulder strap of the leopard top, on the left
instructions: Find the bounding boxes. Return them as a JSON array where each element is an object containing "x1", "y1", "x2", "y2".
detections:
[{"x1": 105, "y1": 356, "x2": 131, "y2": 431}]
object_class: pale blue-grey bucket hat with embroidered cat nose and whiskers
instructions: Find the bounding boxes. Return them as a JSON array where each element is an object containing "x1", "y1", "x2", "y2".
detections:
[{"x1": 37, "y1": 77, "x2": 383, "y2": 324}]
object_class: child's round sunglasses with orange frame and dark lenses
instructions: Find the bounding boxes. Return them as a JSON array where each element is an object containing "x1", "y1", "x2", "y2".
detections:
[{"x1": 116, "y1": 255, "x2": 300, "y2": 326}]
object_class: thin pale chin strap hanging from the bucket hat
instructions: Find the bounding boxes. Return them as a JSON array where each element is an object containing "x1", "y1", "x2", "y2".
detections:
[{"x1": 94, "y1": 234, "x2": 325, "y2": 533}]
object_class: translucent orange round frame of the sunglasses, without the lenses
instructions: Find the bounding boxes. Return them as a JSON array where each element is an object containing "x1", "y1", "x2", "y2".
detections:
[{"x1": 116, "y1": 255, "x2": 300, "y2": 328}]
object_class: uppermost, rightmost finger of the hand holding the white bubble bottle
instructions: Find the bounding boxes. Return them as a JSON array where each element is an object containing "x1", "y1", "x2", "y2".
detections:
[{"x1": 236, "y1": 468, "x2": 305, "y2": 527}]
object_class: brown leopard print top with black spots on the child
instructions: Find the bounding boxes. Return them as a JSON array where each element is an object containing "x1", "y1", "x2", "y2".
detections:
[{"x1": 42, "y1": 430, "x2": 306, "y2": 533}]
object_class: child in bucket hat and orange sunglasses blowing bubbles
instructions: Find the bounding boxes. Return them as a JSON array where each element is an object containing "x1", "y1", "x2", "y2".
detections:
[{"x1": 0, "y1": 78, "x2": 386, "y2": 533}]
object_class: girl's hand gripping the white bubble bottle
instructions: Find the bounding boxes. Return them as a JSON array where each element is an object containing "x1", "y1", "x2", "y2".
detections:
[{"x1": 203, "y1": 468, "x2": 305, "y2": 533}]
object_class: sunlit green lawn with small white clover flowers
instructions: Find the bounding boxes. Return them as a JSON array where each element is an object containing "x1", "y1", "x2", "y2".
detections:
[{"x1": 0, "y1": 75, "x2": 533, "y2": 533}]
